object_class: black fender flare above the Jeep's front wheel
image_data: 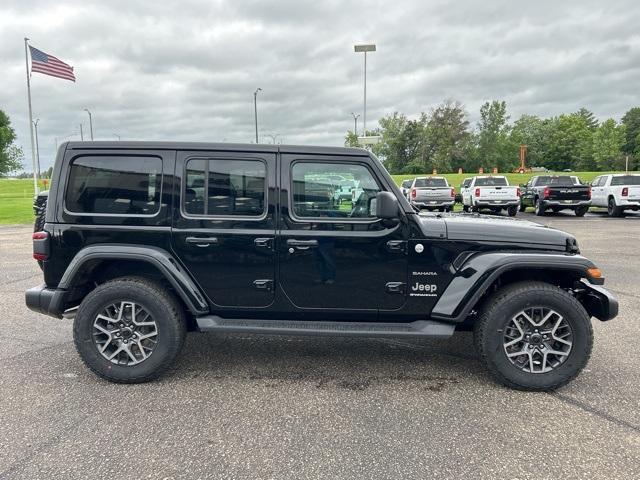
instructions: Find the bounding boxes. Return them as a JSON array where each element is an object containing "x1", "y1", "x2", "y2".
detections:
[{"x1": 430, "y1": 252, "x2": 595, "y2": 322}]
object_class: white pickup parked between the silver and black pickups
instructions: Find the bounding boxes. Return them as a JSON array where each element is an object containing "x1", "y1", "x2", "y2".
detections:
[{"x1": 460, "y1": 176, "x2": 520, "y2": 217}]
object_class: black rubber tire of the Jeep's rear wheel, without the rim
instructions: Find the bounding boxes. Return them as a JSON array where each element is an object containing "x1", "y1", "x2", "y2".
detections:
[{"x1": 73, "y1": 277, "x2": 186, "y2": 383}]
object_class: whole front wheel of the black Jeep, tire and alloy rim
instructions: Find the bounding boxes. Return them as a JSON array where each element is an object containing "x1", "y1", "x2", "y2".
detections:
[{"x1": 474, "y1": 281, "x2": 593, "y2": 391}]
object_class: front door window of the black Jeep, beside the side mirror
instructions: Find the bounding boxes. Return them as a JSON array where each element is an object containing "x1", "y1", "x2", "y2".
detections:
[{"x1": 291, "y1": 162, "x2": 381, "y2": 220}]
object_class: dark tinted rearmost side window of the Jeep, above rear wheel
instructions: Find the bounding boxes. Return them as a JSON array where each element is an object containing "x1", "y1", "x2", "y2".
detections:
[{"x1": 65, "y1": 156, "x2": 162, "y2": 215}]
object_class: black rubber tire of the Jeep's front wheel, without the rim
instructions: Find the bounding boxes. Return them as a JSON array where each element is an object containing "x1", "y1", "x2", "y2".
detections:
[{"x1": 474, "y1": 281, "x2": 593, "y2": 391}]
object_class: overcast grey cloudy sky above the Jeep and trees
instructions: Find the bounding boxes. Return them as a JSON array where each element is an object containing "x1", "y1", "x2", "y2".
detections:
[{"x1": 0, "y1": 0, "x2": 640, "y2": 169}]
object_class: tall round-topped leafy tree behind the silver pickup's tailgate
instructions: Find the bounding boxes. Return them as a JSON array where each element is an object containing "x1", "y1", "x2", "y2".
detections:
[{"x1": 425, "y1": 100, "x2": 471, "y2": 172}]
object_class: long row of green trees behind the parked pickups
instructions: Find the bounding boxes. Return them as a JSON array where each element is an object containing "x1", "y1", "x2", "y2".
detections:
[{"x1": 345, "y1": 100, "x2": 640, "y2": 174}]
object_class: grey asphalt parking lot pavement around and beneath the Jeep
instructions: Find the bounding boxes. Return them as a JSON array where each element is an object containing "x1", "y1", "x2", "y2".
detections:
[{"x1": 0, "y1": 213, "x2": 640, "y2": 479}]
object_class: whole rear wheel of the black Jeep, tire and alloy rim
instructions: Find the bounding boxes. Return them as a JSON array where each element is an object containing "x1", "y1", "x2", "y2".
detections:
[{"x1": 73, "y1": 277, "x2": 186, "y2": 383}]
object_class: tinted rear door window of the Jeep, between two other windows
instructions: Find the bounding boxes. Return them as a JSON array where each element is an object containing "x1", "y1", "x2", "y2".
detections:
[{"x1": 183, "y1": 159, "x2": 267, "y2": 217}]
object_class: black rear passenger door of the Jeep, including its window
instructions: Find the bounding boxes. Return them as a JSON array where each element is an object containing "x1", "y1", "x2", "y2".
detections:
[{"x1": 172, "y1": 152, "x2": 276, "y2": 309}]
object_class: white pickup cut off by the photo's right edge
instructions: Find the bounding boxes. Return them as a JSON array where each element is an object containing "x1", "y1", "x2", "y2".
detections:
[{"x1": 591, "y1": 173, "x2": 640, "y2": 217}]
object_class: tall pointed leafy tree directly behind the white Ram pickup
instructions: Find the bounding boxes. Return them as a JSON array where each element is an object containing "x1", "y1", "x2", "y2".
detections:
[{"x1": 478, "y1": 100, "x2": 518, "y2": 172}]
